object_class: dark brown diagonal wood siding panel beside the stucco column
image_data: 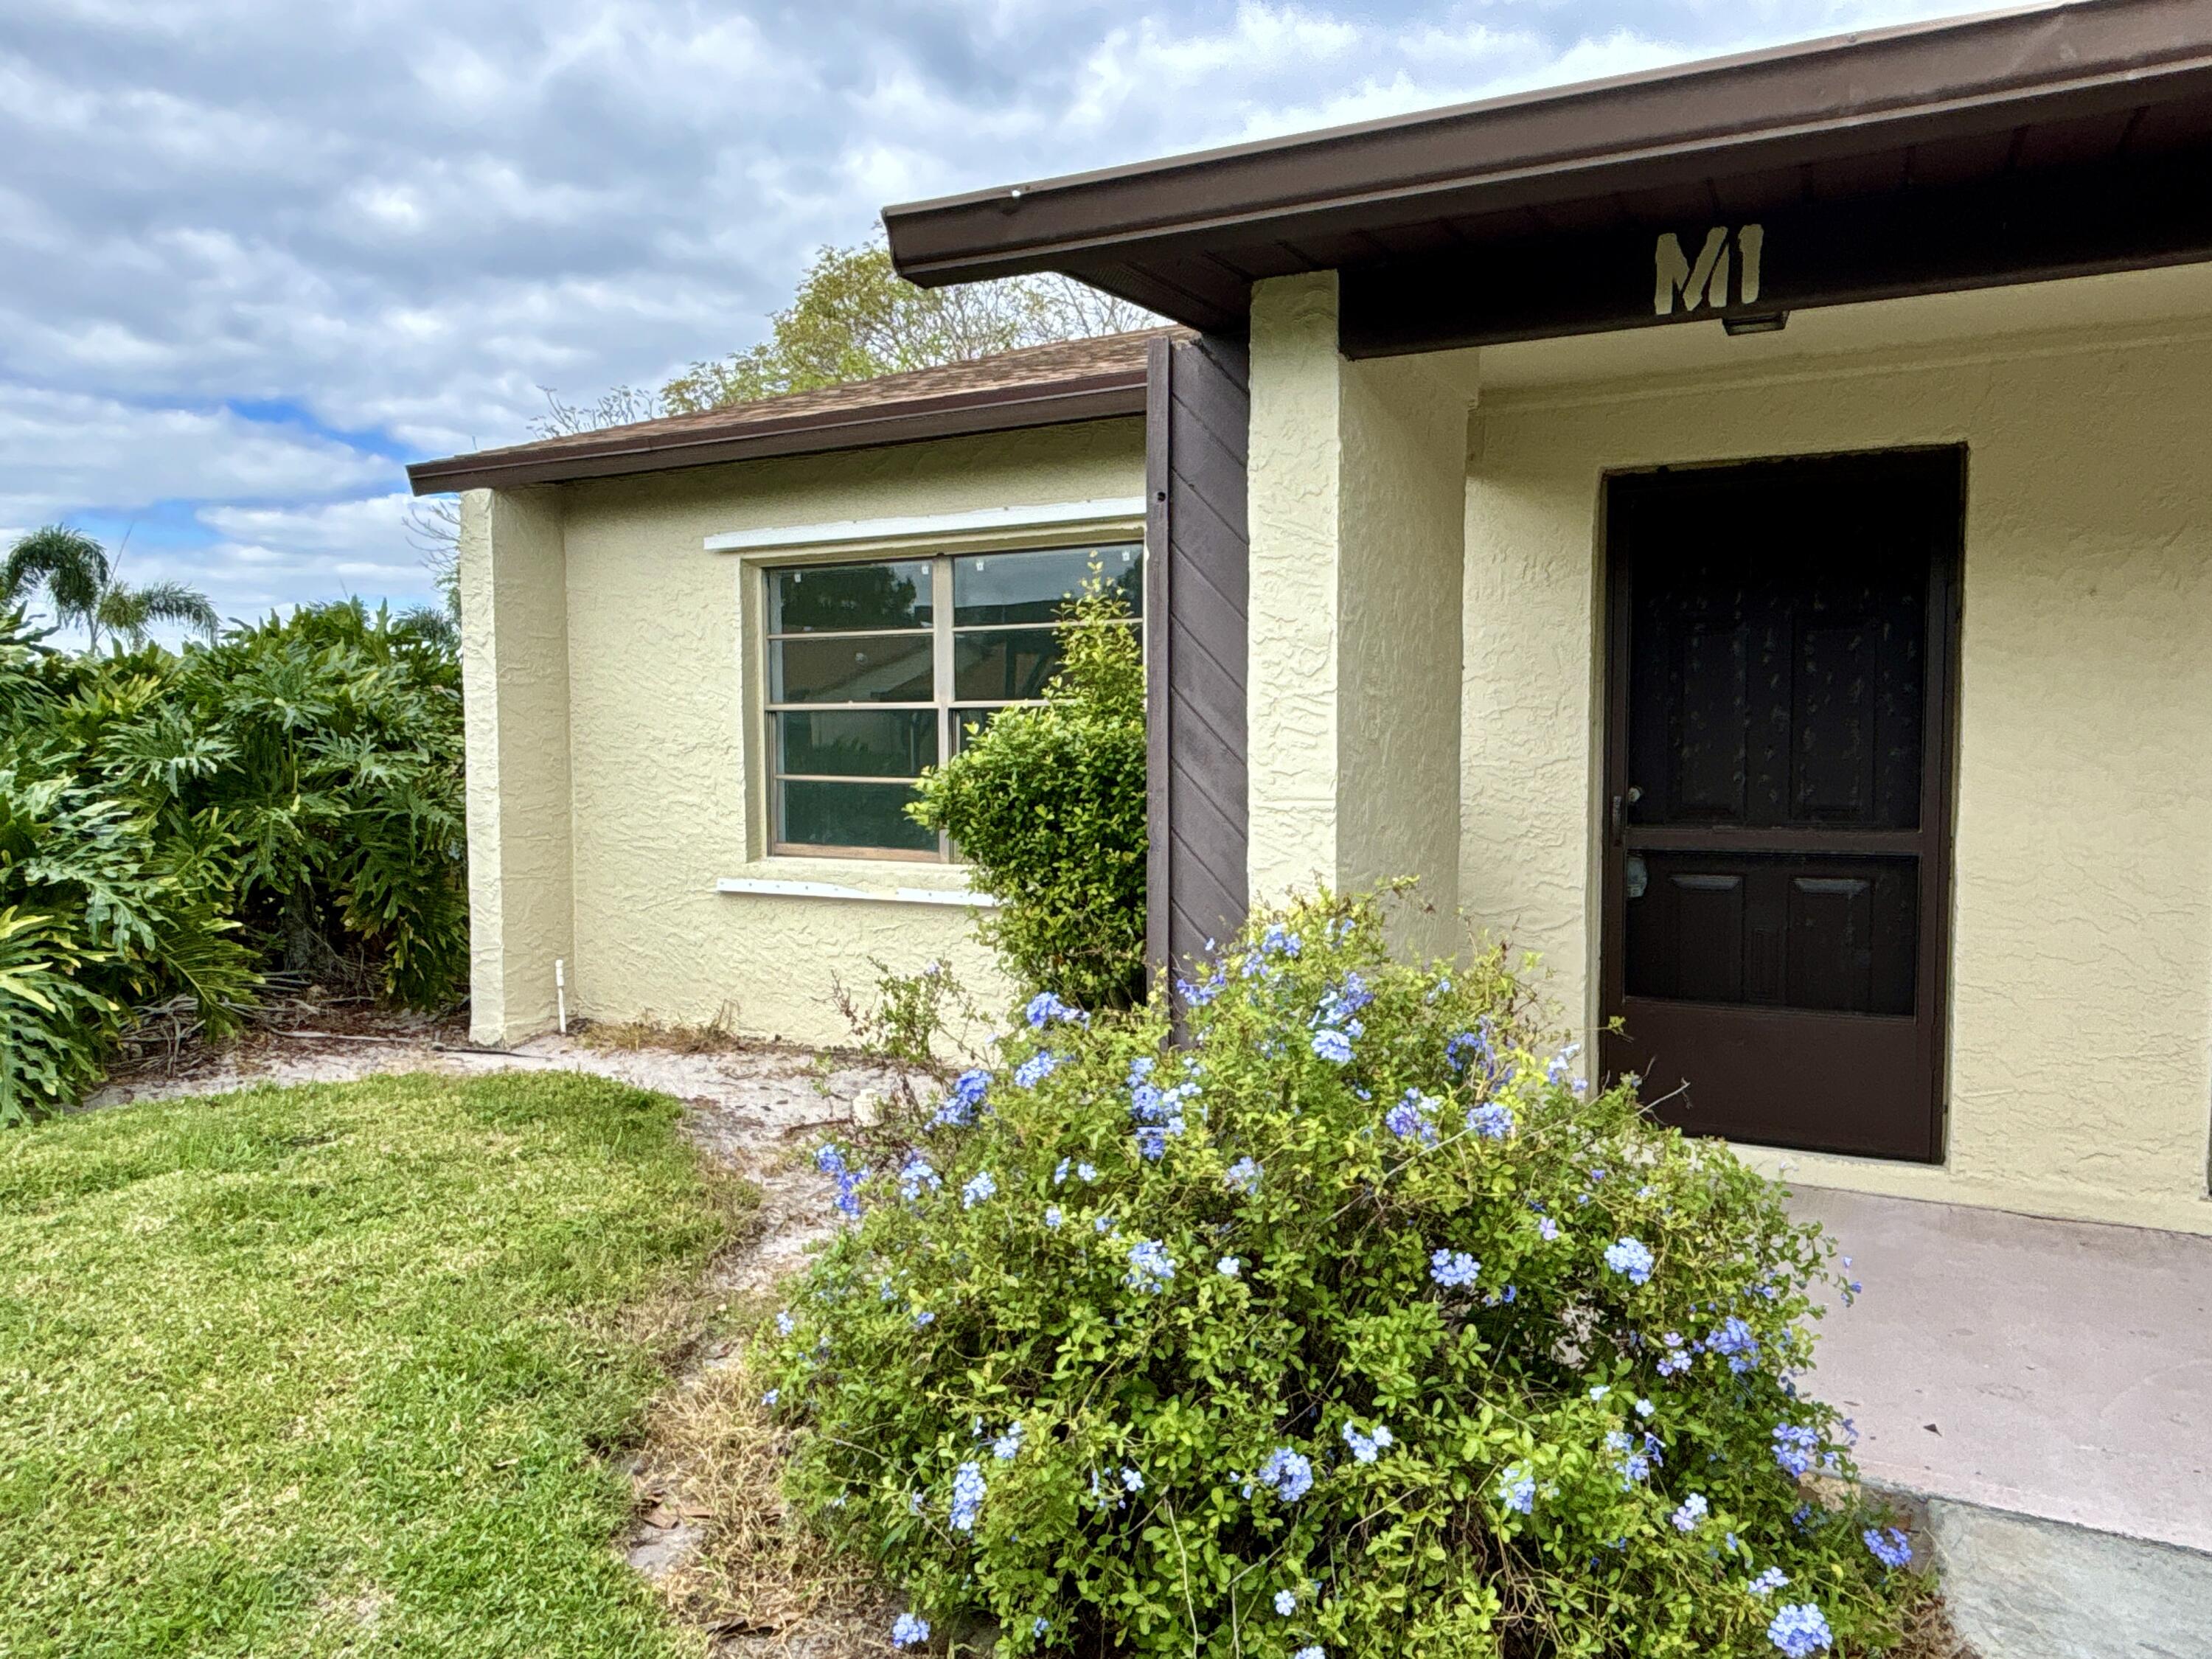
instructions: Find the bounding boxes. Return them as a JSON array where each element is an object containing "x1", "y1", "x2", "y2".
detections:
[{"x1": 1146, "y1": 336, "x2": 1252, "y2": 987}]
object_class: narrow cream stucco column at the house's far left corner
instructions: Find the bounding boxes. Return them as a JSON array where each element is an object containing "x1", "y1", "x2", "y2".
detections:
[{"x1": 460, "y1": 489, "x2": 575, "y2": 1044}]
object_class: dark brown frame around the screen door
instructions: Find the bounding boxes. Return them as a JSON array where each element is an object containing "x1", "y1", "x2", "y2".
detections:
[{"x1": 1597, "y1": 442, "x2": 1969, "y2": 1164}]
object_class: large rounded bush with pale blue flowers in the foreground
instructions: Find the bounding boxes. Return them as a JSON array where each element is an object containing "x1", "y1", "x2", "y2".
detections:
[{"x1": 768, "y1": 902, "x2": 1922, "y2": 1659}]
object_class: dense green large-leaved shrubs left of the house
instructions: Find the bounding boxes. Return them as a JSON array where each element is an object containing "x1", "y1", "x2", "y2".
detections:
[{"x1": 0, "y1": 604, "x2": 469, "y2": 1124}]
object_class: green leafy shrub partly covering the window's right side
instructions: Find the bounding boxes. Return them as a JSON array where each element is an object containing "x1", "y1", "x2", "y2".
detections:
[{"x1": 911, "y1": 582, "x2": 1146, "y2": 1009}]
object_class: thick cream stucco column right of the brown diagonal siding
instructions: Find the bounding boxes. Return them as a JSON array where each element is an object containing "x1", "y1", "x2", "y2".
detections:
[{"x1": 1248, "y1": 272, "x2": 1467, "y2": 951}]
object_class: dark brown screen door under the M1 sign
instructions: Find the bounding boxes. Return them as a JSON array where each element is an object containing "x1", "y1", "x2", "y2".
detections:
[{"x1": 1601, "y1": 449, "x2": 1964, "y2": 1161}]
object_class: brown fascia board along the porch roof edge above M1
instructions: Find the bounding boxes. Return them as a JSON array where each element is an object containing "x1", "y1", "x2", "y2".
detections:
[{"x1": 883, "y1": 0, "x2": 2212, "y2": 285}]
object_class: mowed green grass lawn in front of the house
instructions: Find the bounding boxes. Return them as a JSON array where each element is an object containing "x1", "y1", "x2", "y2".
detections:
[{"x1": 0, "y1": 1073, "x2": 745, "y2": 1659}]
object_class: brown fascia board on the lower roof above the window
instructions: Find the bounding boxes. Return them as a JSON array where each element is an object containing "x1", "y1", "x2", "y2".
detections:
[{"x1": 407, "y1": 367, "x2": 1144, "y2": 495}]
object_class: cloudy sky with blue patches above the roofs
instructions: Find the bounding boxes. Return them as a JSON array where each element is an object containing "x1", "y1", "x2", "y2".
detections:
[{"x1": 0, "y1": 0, "x2": 2000, "y2": 615}]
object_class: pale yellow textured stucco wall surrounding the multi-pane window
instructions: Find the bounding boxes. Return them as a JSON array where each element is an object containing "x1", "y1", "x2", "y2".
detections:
[{"x1": 540, "y1": 420, "x2": 1144, "y2": 1042}]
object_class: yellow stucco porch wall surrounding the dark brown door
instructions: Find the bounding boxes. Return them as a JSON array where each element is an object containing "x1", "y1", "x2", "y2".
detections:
[{"x1": 1460, "y1": 327, "x2": 2212, "y2": 1232}]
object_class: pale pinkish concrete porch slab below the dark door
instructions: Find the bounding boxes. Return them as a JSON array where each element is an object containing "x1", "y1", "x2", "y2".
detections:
[{"x1": 1790, "y1": 1188, "x2": 2212, "y2": 1553}]
